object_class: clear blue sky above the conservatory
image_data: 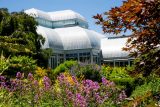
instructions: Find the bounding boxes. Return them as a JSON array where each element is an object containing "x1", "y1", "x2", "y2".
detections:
[{"x1": 0, "y1": 0, "x2": 122, "y2": 33}]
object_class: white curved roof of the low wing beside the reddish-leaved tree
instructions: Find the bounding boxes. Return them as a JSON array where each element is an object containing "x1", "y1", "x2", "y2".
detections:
[{"x1": 101, "y1": 38, "x2": 129, "y2": 59}]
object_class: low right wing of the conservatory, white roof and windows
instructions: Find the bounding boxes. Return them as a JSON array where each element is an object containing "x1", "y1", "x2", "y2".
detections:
[{"x1": 101, "y1": 37, "x2": 134, "y2": 66}]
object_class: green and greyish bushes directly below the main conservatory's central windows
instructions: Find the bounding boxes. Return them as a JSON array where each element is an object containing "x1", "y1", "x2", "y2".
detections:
[{"x1": 53, "y1": 61, "x2": 102, "y2": 81}]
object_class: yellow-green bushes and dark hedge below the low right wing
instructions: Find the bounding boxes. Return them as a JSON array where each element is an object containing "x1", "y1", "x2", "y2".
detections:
[{"x1": 101, "y1": 66, "x2": 137, "y2": 96}]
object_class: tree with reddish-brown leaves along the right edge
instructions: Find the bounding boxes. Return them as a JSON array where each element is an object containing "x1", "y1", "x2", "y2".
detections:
[{"x1": 94, "y1": 0, "x2": 160, "y2": 76}]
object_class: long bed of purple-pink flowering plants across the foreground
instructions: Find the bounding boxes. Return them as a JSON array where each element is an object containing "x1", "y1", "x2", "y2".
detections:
[{"x1": 0, "y1": 72, "x2": 126, "y2": 107}]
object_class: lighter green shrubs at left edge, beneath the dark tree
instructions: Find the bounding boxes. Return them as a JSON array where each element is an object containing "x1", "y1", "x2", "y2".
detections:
[{"x1": 0, "y1": 54, "x2": 38, "y2": 77}]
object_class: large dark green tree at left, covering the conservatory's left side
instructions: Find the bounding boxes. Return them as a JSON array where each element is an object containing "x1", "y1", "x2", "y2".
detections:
[{"x1": 0, "y1": 8, "x2": 51, "y2": 66}]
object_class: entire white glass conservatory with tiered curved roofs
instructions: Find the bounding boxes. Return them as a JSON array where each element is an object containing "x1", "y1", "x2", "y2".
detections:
[{"x1": 25, "y1": 8, "x2": 132, "y2": 68}]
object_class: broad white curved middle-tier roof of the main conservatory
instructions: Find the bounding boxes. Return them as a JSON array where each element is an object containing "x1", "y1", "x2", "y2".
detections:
[{"x1": 37, "y1": 26, "x2": 104, "y2": 50}]
